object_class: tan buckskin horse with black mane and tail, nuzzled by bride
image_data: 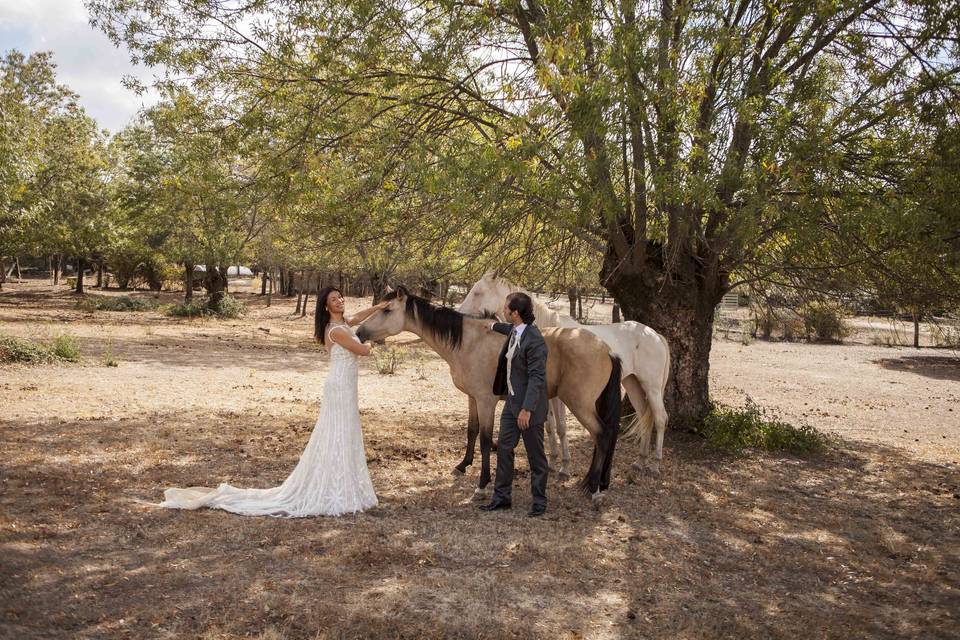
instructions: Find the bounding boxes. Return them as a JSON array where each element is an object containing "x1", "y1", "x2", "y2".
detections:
[{"x1": 357, "y1": 287, "x2": 620, "y2": 501}]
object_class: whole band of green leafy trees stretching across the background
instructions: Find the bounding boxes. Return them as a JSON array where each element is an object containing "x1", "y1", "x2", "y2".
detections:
[{"x1": 0, "y1": 0, "x2": 960, "y2": 426}]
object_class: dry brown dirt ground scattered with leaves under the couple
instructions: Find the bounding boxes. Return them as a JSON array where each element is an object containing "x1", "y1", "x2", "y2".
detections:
[{"x1": 0, "y1": 282, "x2": 960, "y2": 640}]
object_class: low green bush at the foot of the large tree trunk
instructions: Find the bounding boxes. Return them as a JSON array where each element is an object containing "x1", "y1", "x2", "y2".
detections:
[{"x1": 699, "y1": 398, "x2": 830, "y2": 454}]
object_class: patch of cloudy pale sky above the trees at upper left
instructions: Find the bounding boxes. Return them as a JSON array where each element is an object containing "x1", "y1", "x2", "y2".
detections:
[{"x1": 0, "y1": 0, "x2": 156, "y2": 132}]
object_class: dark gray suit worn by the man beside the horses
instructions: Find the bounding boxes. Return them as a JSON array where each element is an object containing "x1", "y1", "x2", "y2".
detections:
[{"x1": 493, "y1": 322, "x2": 548, "y2": 507}]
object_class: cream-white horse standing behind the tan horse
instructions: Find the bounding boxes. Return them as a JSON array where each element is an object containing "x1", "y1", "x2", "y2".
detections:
[{"x1": 459, "y1": 272, "x2": 670, "y2": 473}]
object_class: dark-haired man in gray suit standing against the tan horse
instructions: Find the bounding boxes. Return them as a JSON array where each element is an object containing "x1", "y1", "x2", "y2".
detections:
[{"x1": 480, "y1": 293, "x2": 548, "y2": 518}]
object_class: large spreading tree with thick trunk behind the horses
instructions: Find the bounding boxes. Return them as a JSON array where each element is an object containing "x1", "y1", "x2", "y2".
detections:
[{"x1": 89, "y1": 0, "x2": 960, "y2": 425}]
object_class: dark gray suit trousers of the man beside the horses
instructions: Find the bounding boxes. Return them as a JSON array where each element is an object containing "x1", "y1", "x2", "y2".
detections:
[{"x1": 493, "y1": 407, "x2": 549, "y2": 507}]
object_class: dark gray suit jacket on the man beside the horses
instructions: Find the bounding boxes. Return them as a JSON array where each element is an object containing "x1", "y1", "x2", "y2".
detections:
[{"x1": 493, "y1": 322, "x2": 547, "y2": 424}]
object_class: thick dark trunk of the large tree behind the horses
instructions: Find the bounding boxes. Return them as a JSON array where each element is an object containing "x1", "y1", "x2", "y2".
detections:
[{"x1": 601, "y1": 243, "x2": 728, "y2": 429}]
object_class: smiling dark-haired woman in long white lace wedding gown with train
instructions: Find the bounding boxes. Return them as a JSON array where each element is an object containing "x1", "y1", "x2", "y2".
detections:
[{"x1": 160, "y1": 287, "x2": 386, "y2": 518}]
